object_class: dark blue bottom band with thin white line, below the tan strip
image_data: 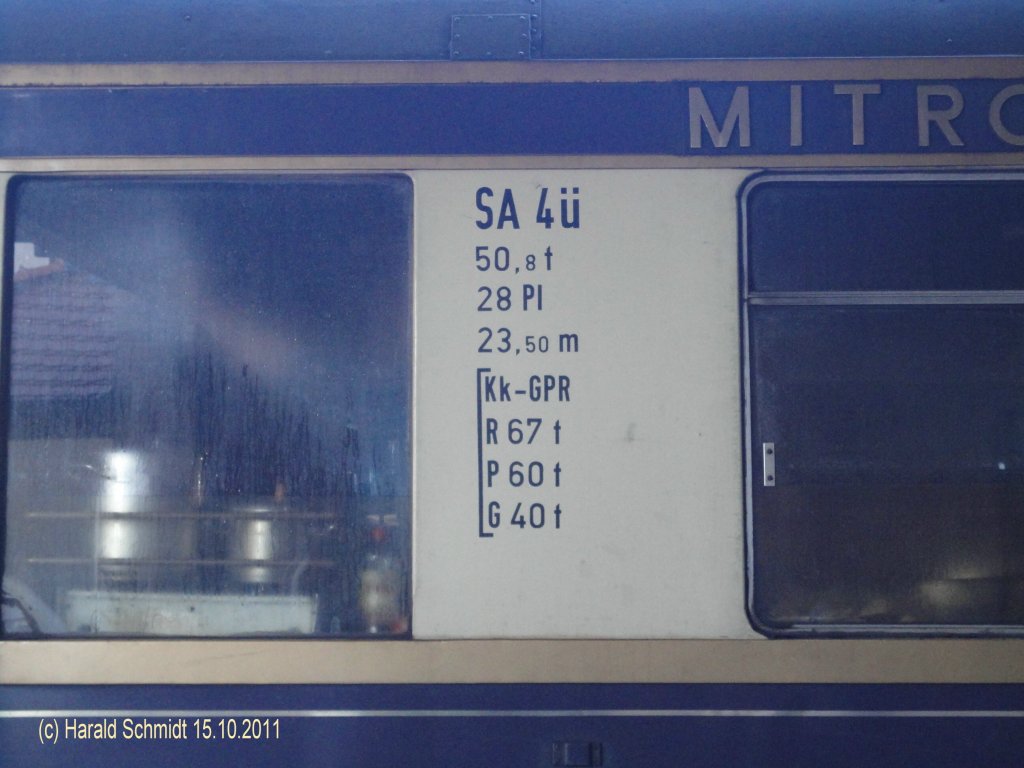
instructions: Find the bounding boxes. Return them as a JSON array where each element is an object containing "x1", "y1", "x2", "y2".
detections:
[{"x1": 0, "y1": 685, "x2": 1024, "y2": 768}]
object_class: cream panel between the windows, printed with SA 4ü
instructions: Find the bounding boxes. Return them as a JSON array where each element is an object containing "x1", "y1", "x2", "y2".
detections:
[{"x1": 413, "y1": 170, "x2": 753, "y2": 638}]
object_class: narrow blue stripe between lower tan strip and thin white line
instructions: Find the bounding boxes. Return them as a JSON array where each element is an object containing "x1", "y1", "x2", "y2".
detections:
[{"x1": 0, "y1": 683, "x2": 1024, "y2": 712}]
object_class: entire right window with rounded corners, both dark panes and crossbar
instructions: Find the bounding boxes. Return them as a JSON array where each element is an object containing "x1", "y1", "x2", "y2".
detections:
[{"x1": 742, "y1": 175, "x2": 1024, "y2": 634}]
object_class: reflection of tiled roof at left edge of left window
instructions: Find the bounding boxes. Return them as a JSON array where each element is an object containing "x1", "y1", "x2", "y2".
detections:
[{"x1": 10, "y1": 261, "x2": 130, "y2": 399}]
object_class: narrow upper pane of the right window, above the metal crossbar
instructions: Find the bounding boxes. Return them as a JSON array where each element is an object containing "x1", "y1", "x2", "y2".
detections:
[{"x1": 746, "y1": 178, "x2": 1024, "y2": 291}]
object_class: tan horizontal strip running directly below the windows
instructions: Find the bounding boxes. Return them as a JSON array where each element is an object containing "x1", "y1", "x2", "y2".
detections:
[{"x1": 6, "y1": 640, "x2": 1024, "y2": 685}]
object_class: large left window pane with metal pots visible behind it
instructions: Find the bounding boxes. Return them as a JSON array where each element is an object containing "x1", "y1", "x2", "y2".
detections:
[{"x1": 3, "y1": 176, "x2": 412, "y2": 636}]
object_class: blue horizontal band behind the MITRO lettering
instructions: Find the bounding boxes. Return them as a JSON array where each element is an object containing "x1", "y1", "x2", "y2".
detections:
[{"x1": 0, "y1": 80, "x2": 1024, "y2": 157}]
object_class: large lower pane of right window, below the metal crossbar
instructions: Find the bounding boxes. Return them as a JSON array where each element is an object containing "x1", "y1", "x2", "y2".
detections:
[{"x1": 751, "y1": 306, "x2": 1024, "y2": 630}]
